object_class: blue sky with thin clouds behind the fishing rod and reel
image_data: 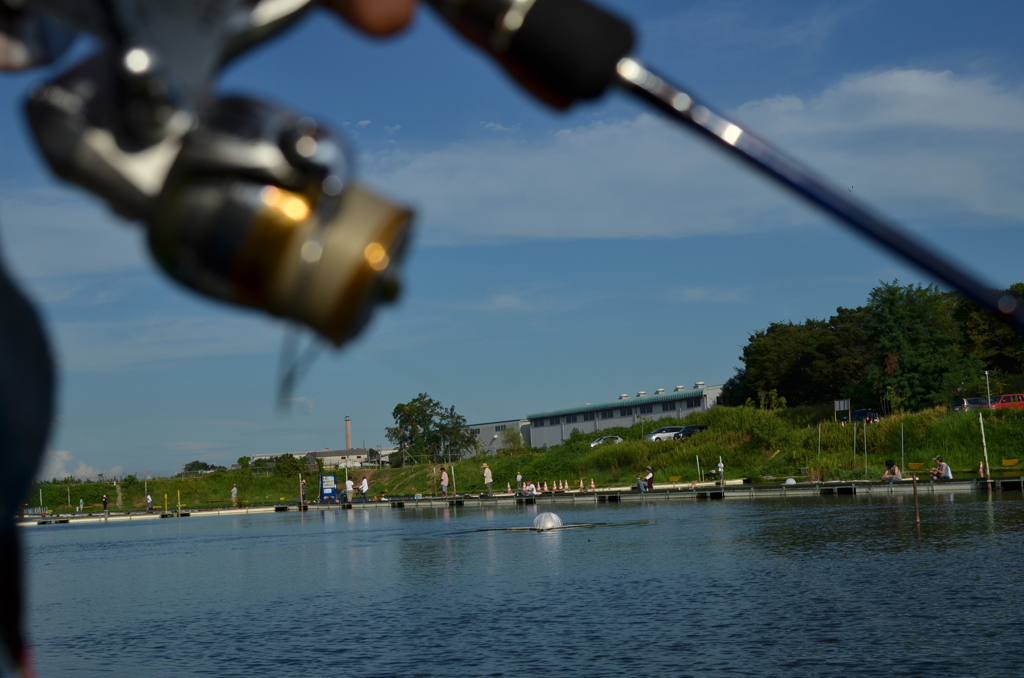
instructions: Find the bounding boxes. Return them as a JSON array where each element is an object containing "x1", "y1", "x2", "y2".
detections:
[{"x1": 6, "y1": 0, "x2": 1024, "y2": 476}]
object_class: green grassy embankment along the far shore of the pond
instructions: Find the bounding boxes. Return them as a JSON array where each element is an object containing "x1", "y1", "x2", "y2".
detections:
[{"x1": 27, "y1": 408, "x2": 1024, "y2": 510}]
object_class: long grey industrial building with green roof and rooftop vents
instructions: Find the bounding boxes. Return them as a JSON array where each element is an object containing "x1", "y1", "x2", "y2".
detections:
[{"x1": 527, "y1": 381, "x2": 722, "y2": 448}]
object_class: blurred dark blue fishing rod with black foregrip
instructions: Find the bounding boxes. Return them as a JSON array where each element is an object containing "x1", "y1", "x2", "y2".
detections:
[{"x1": 427, "y1": 0, "x2": 1024, "y2": 332}]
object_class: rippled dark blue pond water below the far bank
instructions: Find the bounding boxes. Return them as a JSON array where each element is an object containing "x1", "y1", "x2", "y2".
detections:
[{"x1": 23, "y1": 494, "x2": 1024, "y2": 677}]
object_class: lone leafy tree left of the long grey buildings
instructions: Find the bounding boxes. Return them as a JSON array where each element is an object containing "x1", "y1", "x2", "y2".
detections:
[{"x1": 386, "y1": 393, "x2": 476, "y2": 465}]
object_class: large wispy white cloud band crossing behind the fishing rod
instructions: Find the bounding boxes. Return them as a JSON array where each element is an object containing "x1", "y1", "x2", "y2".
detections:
[{"x1": 366, "y1": 70, "x2": 1024, "y2": 244}]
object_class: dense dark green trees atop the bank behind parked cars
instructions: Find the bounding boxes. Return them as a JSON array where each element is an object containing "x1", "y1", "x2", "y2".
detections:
[{"x1": 723, "y1": 281, "x2": 1024, "y2": 414}]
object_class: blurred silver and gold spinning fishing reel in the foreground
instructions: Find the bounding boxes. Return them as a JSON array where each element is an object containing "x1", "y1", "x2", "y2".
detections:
[{"x1": 7, "y1": 0, "x2": 412, "y2": 346}]
